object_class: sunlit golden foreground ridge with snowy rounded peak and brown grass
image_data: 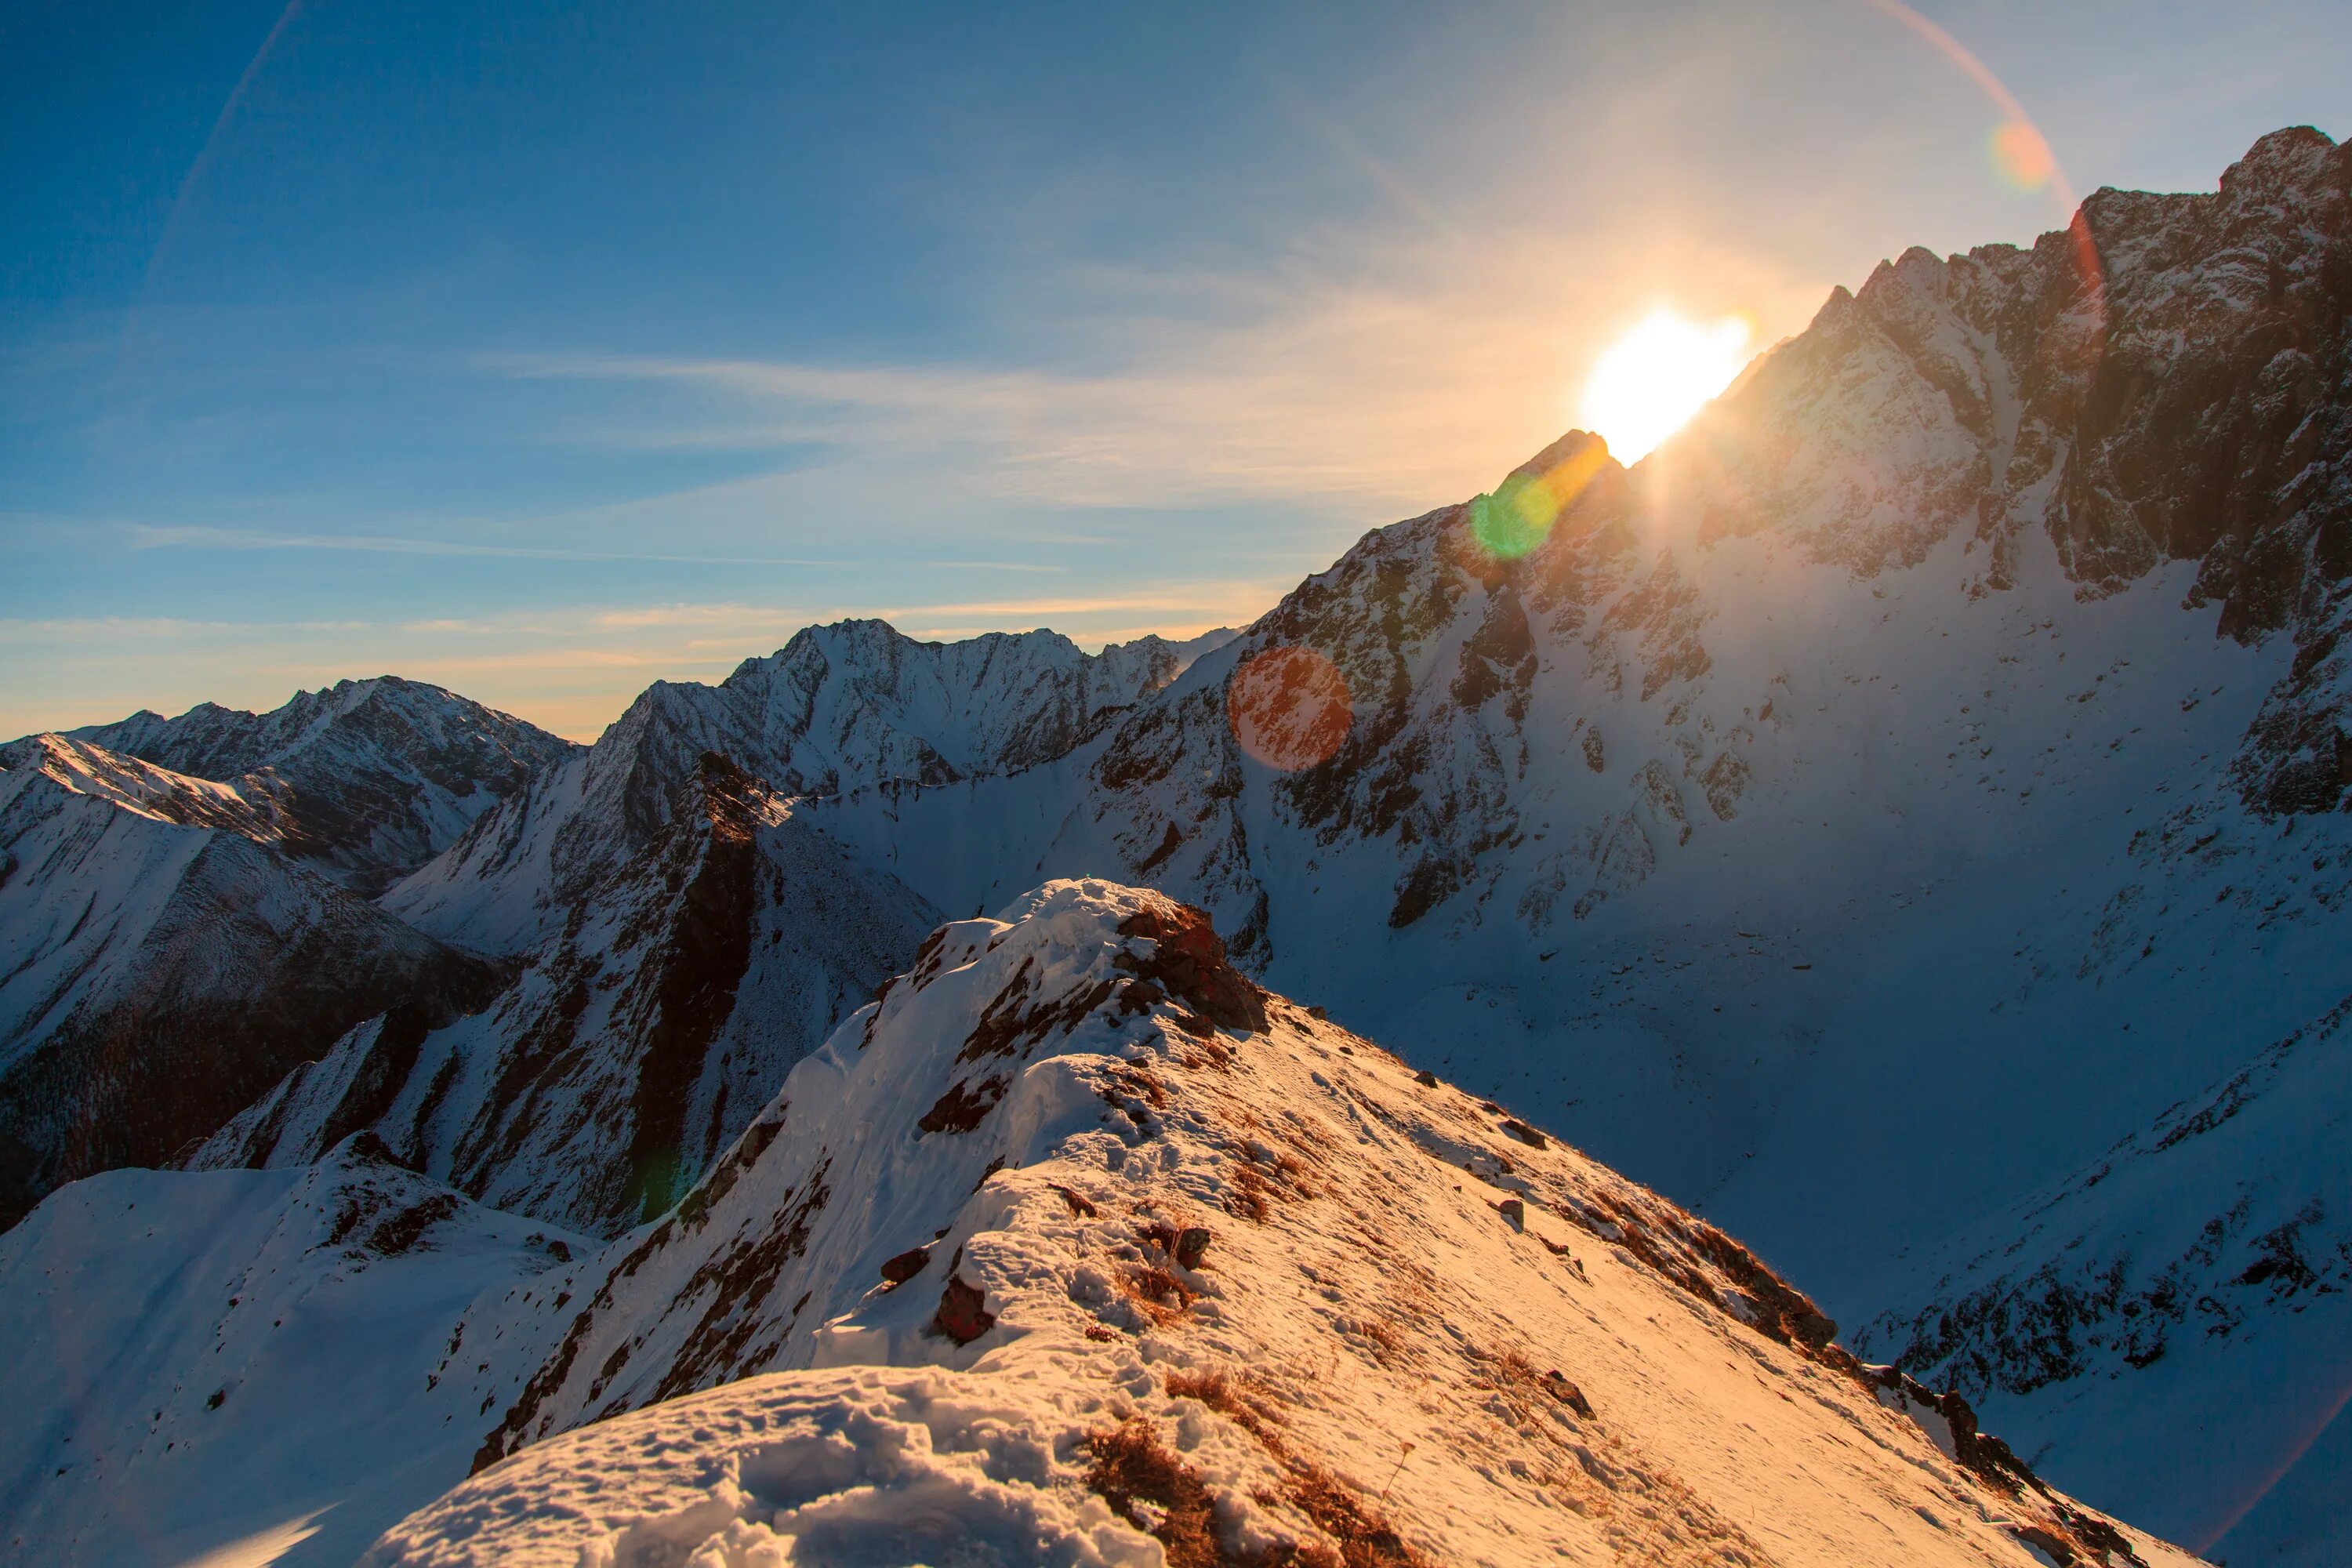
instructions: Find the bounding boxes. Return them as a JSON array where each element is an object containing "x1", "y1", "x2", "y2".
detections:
[{"x1": 367, "y1": 881, "x2": 2187, "y2": 1568}]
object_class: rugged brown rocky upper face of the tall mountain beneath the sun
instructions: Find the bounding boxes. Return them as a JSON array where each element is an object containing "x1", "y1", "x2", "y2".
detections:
[{"x1": 1054, "y1": 129, "x2": 2352, "y2": 956}]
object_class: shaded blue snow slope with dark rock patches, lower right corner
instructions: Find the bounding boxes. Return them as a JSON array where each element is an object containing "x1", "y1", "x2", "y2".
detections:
[{"x1": 1858, "y1": 1001, "x2": 2352, "y2": 1566}]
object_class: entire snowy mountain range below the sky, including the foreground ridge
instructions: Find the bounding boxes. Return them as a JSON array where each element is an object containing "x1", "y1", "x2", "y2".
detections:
[{"x1": 0, "y1": 129, "x2": 2352, "y2": 1568}]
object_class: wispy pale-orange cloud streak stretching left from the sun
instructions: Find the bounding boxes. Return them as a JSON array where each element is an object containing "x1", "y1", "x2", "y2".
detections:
[{"x1": 480, "y1": 223, "x2": 1828, "y2": 517}]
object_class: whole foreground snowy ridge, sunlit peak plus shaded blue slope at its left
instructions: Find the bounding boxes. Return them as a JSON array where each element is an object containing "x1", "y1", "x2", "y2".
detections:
[{"x1": 0, "y1": 881, "x2": 2190, "y2": 1568}]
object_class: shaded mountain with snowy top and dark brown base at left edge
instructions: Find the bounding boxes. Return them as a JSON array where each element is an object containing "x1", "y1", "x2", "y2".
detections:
[{"x1": 0, "y1": 766, "x2": 501, "y2": 1225}]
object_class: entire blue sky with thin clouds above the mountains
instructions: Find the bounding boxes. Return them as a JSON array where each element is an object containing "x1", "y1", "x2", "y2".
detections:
[{"x1": 0, "y1": 0, "x2": 2352, "y2": 736}]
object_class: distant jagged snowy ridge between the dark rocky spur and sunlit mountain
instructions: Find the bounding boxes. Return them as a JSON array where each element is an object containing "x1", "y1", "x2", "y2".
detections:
[{"x1": 383, "y1": 621, "x2": 1232, "y2": 952}]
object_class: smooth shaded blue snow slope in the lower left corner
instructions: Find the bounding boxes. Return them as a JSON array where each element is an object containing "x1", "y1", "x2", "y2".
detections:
[{"x1": 0, "y1": 1138, "x2": 588, "y2": 1568}]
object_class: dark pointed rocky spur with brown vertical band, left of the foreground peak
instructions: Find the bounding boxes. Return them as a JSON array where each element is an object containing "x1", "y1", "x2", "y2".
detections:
[{"x1": 188, "y1": 755, "x2": 938, "y2": 1234}]
